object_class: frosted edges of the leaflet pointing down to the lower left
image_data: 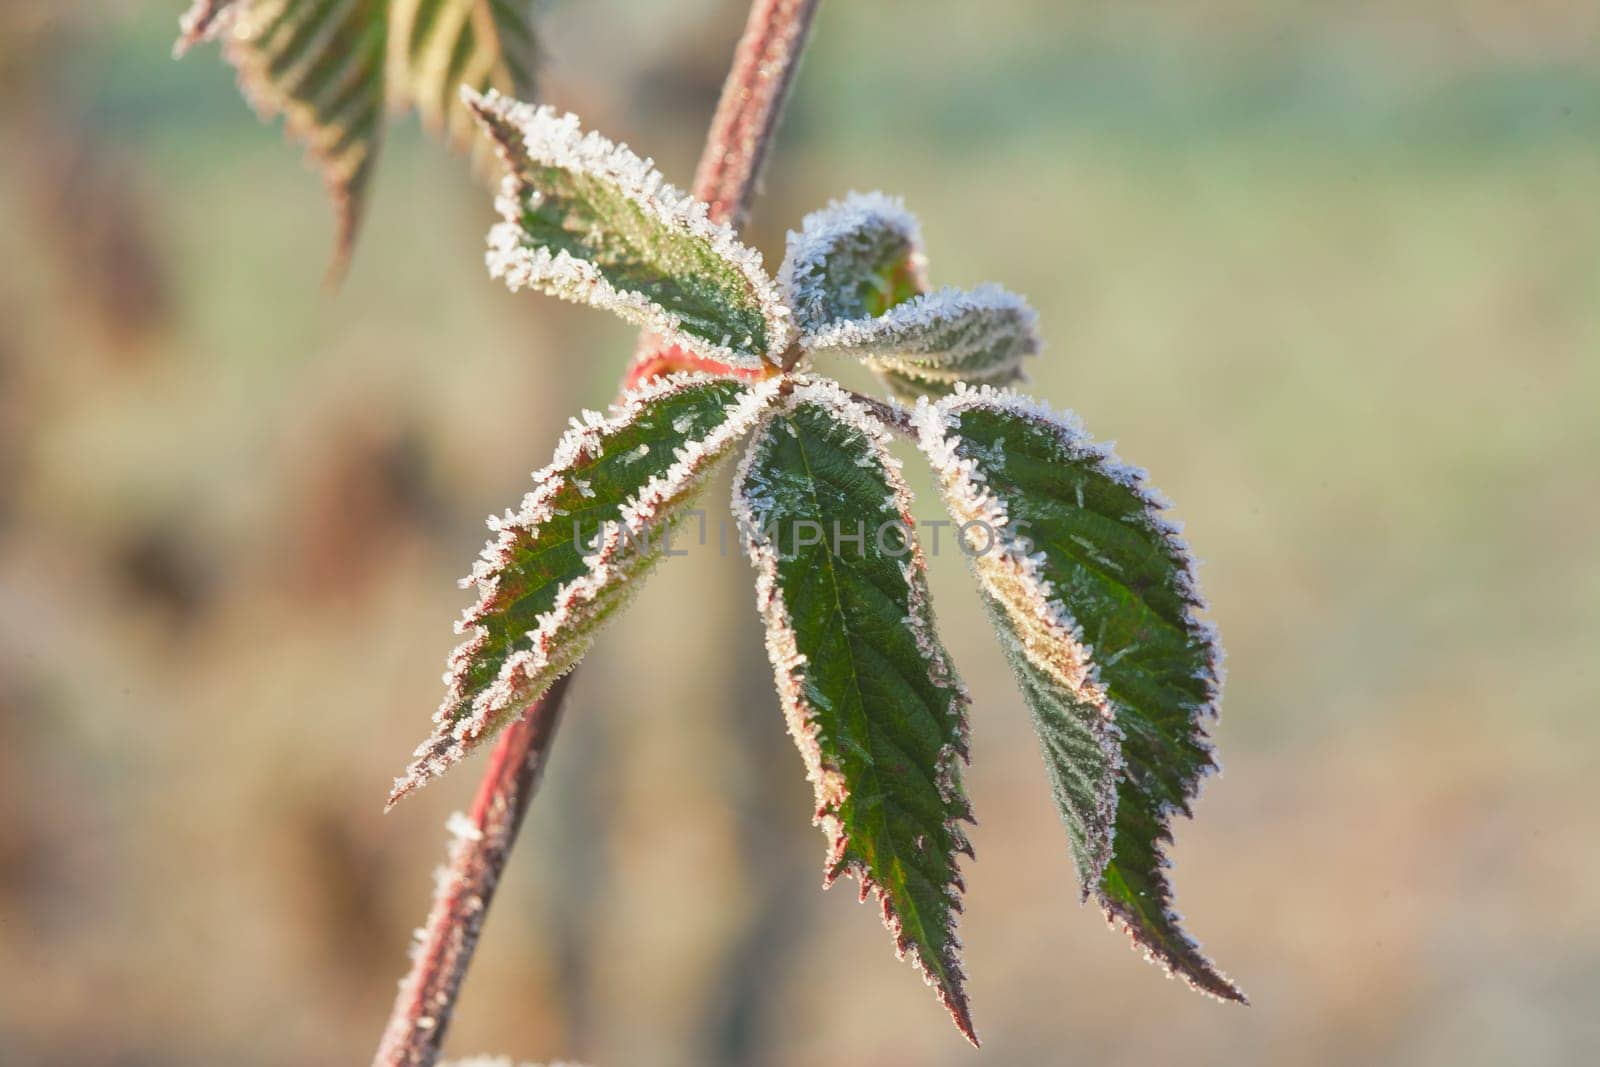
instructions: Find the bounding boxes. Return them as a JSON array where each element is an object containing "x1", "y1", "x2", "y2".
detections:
[{"x1": 389, "y1": 374, "x2": 781, "y2": 806}]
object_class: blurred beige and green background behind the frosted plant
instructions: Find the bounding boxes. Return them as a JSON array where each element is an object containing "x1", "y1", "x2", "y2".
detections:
[{"x1": 0, "y1": 0, "x2": 1600, "y2": 1067}]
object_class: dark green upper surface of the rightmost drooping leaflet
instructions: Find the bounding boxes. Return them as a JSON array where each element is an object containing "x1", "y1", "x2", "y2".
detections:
[{"x1": 918, "y1": 390, "x2": 1243, "y2": 1000}]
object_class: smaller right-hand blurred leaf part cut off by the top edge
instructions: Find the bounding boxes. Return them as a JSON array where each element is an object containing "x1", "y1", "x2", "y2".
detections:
[{"x1": 389, "y1": 0, "x2": 539, "y2": 146}]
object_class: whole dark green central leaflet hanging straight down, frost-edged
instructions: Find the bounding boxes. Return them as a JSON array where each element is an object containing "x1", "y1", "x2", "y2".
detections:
[{"x1": 733, "y1": 379, "x2": 976, "y2": 1043}]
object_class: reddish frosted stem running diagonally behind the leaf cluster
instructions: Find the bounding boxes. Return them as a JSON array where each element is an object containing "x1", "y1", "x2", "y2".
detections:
[{"x1": 373, "y1": 0, "x2": 818, "y2": 1067}]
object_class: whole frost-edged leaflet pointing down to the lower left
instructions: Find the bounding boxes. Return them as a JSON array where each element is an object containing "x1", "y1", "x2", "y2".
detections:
[{"x1": 389, "y1": 376, "x2": 778, "y2": 803}]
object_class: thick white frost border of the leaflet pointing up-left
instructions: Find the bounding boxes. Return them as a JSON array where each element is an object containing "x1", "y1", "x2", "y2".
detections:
[{"x1": 461, "y1": 88, "x2": 794, "y2": 368}]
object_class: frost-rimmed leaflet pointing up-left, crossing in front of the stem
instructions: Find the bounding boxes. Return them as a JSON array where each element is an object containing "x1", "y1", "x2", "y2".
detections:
[{"x1": 466, "y1": 93, "x2": 792, "y2": 366}]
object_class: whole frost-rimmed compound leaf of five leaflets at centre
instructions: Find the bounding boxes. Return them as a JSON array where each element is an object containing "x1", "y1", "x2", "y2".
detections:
[{"x1": 384, "y1": 94, "x2": 1243, "y2": 1041}]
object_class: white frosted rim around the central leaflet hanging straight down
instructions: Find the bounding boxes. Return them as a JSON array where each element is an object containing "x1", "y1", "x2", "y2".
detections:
[{"x1": 731, "y1": 378, "x2": 978, "y2": 1046}]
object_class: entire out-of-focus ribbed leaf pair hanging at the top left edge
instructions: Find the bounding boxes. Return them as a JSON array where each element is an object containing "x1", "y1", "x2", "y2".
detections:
[{"x1": 173, "y1": 0, "x2": 539, "y2": 274}]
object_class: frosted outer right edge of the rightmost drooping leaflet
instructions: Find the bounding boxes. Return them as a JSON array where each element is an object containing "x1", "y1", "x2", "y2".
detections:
[{"x1": 912, "y1": 386, "x2": 1250, "y2": 1003}]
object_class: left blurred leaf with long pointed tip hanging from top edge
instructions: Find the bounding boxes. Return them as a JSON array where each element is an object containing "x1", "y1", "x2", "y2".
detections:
[{"x1": 209, "y1": 0, "x2": 389, "y2": 274}]
